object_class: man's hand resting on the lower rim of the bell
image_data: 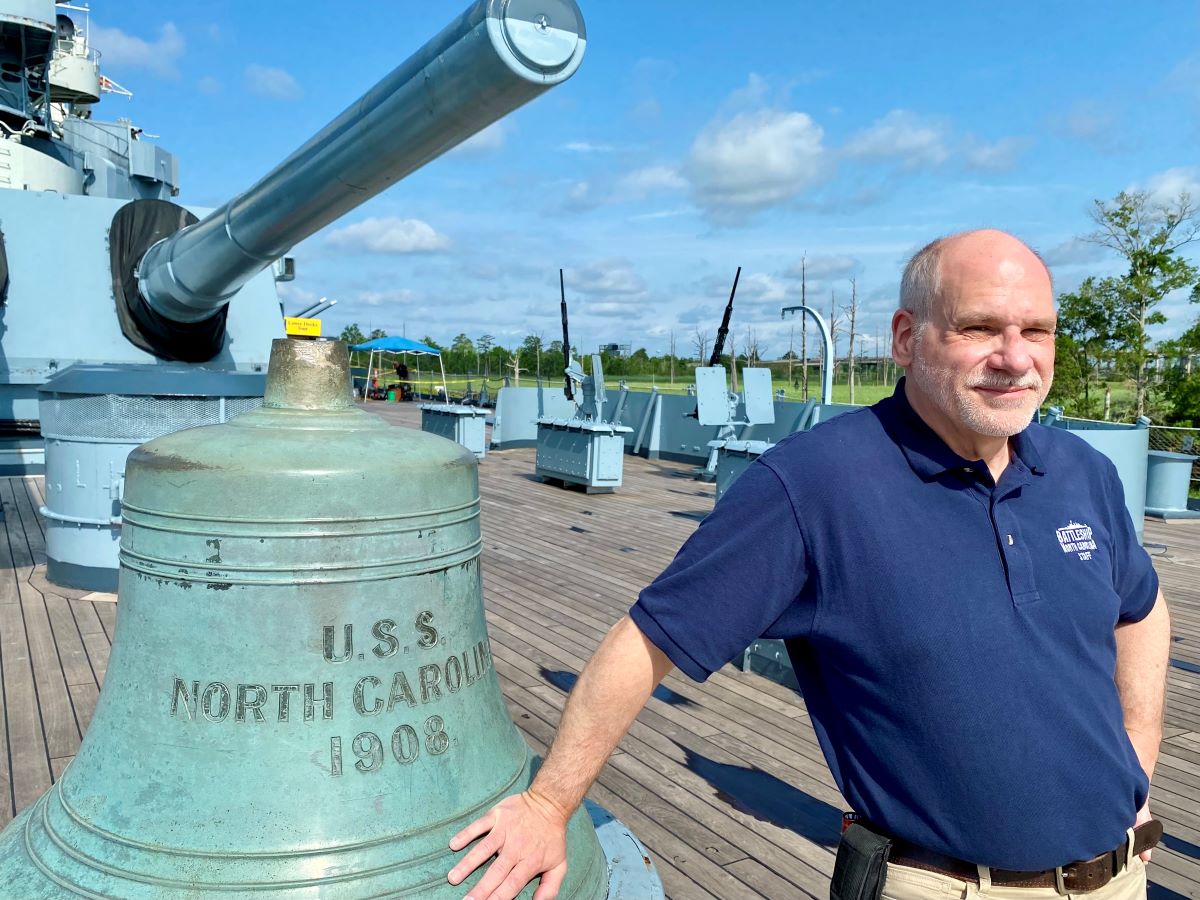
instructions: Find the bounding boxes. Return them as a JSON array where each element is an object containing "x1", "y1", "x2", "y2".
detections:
[{"x1": 448, "y1": 790, "x2": 570, "y2": 900}]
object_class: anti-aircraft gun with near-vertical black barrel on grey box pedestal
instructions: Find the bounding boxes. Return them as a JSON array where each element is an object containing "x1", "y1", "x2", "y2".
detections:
[{"x1": 535, "y1": 269, "x2": 634, "y2": 493}]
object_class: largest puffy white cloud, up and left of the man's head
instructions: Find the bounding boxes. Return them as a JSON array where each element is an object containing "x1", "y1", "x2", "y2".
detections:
[{"x1": 684, "y1": 105, "x2": 828, "y2": 218}]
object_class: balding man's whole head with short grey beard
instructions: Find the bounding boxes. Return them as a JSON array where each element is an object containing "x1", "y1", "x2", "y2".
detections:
[{"x1": 892, "y1": 229, "x2": 1056, "y2": 452}]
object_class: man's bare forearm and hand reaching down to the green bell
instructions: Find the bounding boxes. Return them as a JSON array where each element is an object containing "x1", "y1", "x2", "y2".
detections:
[{"x1": 448, "y1": 616, "x2": 672, "y2": 900}]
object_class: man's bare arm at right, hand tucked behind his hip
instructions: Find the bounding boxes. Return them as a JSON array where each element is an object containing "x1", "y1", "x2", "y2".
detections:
[{"x1": 1116, "y1": 590, "x2": 1171, "y2": 862}]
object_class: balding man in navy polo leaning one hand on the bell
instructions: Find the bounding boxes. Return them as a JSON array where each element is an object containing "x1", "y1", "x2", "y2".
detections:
[{"x1": 450, "y1": 230, "x2": 1170, "y2": 900}]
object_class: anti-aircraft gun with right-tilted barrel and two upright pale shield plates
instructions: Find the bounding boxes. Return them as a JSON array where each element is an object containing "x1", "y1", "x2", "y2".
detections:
[{"x1": 690, "y1": 265, "x2": 775, "y2": 481}]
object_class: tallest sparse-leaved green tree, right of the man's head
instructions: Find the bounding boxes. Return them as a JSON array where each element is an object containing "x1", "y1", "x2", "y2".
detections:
[{"x1": 1085, "y1": 191, "x2": 1200, "y2": 415}]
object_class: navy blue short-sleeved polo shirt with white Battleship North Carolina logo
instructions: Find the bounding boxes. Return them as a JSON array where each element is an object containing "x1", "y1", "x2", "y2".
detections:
[{"x1": 630, "y1": 382, "x2": 1158, "y2": 870}]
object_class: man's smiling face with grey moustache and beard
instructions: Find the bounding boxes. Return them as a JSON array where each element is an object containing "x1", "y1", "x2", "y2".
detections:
[{"x1": 907, "y1": 248, "x2": 1056, "y2": 444}]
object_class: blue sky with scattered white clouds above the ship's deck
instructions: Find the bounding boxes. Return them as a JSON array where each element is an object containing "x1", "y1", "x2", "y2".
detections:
[{"x1": 79, "y1": 0, "x2": 1200, "y2": 356}]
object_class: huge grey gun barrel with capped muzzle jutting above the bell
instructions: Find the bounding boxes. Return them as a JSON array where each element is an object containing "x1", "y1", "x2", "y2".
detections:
[{"x1": 137, "y1": 0, "x2": 587, "y2": 323}]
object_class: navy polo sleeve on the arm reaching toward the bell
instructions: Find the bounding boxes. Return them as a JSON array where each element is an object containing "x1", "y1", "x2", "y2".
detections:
[{"x1": 630, "y1": 461, "x2": 811, "y2": 682}]
